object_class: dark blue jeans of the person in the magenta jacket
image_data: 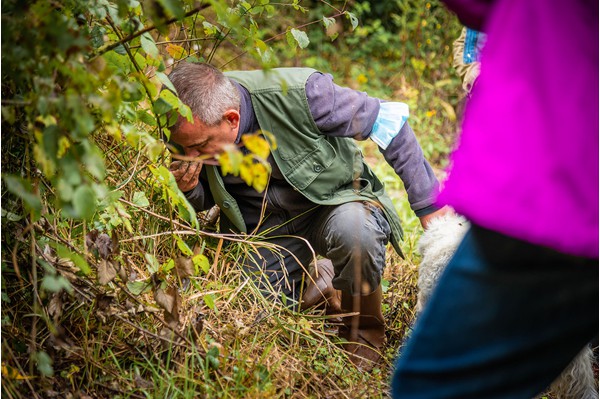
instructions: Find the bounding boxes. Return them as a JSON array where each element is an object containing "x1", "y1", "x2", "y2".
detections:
[{"x1": 392, "y1": 226, "x2": 598, "y2": 399}]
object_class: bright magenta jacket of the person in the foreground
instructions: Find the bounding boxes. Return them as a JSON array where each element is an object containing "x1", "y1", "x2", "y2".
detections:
[{"x1": 439, "y1": 0, "x2": 599, "y2": 258}]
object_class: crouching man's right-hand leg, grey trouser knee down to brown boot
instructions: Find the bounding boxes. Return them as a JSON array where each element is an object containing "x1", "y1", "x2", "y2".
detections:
[{"x1": 311, "y1": 202, "x2": 390, "y2": 370}]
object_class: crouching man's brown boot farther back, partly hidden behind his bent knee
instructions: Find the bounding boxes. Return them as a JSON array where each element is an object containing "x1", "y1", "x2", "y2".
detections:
[{"x1": 300, "y1": 259, "x2": 342, "y2": 315}]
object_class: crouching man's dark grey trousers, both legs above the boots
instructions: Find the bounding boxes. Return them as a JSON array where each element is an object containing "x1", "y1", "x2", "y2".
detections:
[{"x1": 245, "y1": 202, "x2": 391, "y2": 301}]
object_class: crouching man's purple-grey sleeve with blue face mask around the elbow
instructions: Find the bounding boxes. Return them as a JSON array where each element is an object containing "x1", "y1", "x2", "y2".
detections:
[{"x1": 306, "y1": 73, "x2": 439, "y2": 217}]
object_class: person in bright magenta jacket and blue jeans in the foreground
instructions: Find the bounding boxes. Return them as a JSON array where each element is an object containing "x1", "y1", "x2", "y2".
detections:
[{"x1": 392, "y1": 0, "x2": 599, "y2": 399}]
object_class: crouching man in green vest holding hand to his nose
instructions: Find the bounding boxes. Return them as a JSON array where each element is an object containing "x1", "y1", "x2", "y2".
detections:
[{"x1": 169, "y1": 63, "x2": 446, "y2": 369}]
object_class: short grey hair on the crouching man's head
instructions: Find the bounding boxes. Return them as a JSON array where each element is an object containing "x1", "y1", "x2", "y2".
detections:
[{"x1": 169, "y1": 62, "x2": 240, "y2": 126}]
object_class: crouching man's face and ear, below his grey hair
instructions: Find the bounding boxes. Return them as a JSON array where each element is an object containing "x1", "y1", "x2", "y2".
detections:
[{"x1": 171, "y1": 111, "x2": 239, "y2": 157}]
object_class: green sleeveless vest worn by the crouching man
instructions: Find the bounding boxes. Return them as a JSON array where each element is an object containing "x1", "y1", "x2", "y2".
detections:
[{"x1": 205, "y1": 68, "x2": 402, "y2": 254}]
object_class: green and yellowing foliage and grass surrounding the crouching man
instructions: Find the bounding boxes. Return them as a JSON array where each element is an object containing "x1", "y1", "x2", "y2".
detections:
[{"x1": 1, "y1": 0, "x2": 462, "y2": 398}]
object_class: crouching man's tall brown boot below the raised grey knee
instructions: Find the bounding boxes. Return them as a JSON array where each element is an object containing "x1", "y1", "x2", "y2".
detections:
[{"x1": 338, "y1": 287, "x2": 385, "y2": 371}]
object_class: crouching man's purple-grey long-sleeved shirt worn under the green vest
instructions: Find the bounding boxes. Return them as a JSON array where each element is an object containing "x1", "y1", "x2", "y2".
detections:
[{"x1": 186, "y1": 73, "x2": 438, "y2": 233}]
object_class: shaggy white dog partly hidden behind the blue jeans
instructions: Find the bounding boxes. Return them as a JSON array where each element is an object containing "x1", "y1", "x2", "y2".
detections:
[{"x1": 416, "y1": 215, "x2": 598, "y2": 399}]
